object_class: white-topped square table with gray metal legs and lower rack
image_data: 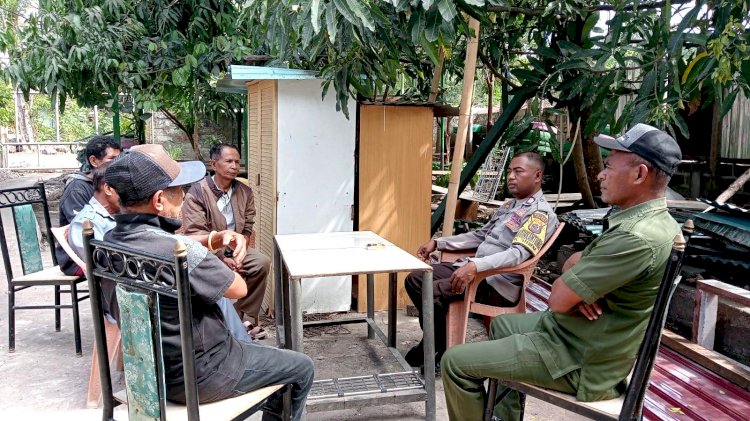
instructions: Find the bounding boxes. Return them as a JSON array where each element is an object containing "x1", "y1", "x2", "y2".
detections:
[{"x1": 274, "y1": 231, "x2": 435, "y2": 420}]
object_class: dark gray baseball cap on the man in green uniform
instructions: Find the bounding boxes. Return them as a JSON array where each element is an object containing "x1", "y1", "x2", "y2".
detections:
[{"x1": 594, "y1": 123, "x2": 682, "y2": 176}]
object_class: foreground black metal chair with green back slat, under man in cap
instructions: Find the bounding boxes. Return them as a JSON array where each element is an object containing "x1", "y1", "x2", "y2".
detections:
[{"x1": 83, "y1": 221, "x2": 288, "y2": 421}]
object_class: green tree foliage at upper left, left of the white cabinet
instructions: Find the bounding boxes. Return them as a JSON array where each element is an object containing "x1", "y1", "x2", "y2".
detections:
[{"x1": 0, "y1": 0, "x2": 250, "y2": 158}]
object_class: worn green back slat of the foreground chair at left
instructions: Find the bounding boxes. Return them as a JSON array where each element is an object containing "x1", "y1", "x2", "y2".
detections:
[{"x1": 117, "y1": 285, "x2": 161, "y2": 421}]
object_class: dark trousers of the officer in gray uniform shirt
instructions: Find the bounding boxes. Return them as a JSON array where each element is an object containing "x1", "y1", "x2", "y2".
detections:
[{"x1": 404, "y1": 263, "x2": 514, "y2": 361}]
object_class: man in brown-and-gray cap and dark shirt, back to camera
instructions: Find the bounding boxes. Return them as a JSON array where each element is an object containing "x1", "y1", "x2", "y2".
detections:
[{"x1": 104, "y1": 145, "x2": 313, "y2": 420}]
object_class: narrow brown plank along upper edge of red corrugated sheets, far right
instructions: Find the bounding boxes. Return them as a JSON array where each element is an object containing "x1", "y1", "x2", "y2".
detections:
[{"x1": 661, "y1": 329, "x2": 750, "y2": 390}]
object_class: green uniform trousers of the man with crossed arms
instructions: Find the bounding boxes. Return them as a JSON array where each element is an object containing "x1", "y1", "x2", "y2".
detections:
[{"x1": 441, "y1": 312, "x2": 579, "y2": 421}]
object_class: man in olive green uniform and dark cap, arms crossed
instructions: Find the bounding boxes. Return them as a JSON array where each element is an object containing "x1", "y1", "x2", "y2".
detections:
[{"x1": 442, "y1": 124, "x2": 682, "y2": 421}]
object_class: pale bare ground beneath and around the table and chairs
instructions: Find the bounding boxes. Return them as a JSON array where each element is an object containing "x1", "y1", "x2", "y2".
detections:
[{"x1": 0, "y1": 174, "x2": 584, "y2": 420}]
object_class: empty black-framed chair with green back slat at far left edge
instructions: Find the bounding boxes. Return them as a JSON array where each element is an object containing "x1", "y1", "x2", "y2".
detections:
[{"x1": 0, "y1": 182, "x2": 89, "y2": 356}]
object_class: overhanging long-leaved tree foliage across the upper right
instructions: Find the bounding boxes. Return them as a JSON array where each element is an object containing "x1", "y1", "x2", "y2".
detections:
[{"x1": 243, "y1": 0, "x2": 750, "y2": 205}]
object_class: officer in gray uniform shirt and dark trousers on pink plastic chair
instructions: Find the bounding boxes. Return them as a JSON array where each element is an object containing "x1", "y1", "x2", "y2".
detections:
[{"x1": 405, "y1": 152, "x2": 558, "y2": 367}]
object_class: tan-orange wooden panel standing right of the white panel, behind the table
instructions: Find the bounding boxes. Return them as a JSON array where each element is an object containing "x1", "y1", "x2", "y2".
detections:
[{"x1": 358, "y1": 105, "x2": 433, "y2": 311}]
